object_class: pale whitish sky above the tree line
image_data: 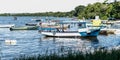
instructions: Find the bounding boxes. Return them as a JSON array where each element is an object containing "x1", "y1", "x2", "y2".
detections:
[{"x1": 0, "y1": 0, "x2": 115, "y2": 13}]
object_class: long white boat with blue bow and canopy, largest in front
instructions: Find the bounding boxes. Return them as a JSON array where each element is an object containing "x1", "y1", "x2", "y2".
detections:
[{"x1": 41, "y1": 21, "x2": 101, "y2": 37}]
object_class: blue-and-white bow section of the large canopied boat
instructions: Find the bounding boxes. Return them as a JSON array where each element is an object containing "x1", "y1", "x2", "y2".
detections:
[{"x1": 78, "y1": 23, "x2": 102, "y2": 36}]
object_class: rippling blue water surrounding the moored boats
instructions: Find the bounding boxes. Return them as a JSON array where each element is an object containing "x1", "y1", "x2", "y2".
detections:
[{"x1": 0, "y1": 16, "x2": 120, "y2": 60}]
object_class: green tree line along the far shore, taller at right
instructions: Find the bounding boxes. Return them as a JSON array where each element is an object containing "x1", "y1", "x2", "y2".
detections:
[{"x1": 0, "y1": 1, "x2": 120, "y2": 19}]
